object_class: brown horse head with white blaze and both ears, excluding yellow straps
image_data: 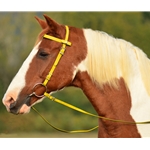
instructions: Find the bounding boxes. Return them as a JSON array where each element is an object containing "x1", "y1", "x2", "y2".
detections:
[{"x1": 3, "y1": 15, "x2": 85, "y2": 114}]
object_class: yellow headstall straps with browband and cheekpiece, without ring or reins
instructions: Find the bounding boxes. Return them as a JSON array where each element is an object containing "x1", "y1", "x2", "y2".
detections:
[{"x1": 43, "y1": 26, "x2": 71, "y2": 86}]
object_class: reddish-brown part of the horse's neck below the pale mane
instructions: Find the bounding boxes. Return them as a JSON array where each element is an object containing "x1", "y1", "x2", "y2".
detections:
[{"x1": 73, "y1": 72, "x2": 140, "y2": 137}]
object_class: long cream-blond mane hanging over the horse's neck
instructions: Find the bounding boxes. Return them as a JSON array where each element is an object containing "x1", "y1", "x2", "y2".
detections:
[{"x1": 84, "y1": 29, "x2": 150, "y2": 95}]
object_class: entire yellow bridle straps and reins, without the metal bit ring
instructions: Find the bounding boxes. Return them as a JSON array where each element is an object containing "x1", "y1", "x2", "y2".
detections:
[{"x1": 32, "y1": 26, "x2": 150, "y2": 133}]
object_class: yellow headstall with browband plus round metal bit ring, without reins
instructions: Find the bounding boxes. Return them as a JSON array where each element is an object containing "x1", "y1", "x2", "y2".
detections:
[{"x1": 29, "y1": 26, "x2": 71, "y2": 98}]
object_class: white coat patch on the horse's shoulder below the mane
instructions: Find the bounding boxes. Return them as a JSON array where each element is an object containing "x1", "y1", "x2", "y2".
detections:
[{"x1": 129, "y1": 65, "x2": 150, "y2": 137}]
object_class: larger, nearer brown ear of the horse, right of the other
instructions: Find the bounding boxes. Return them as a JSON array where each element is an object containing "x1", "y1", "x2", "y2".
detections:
[{"x1": 43, "y1": 15, "x2": 60, "y2": 31}]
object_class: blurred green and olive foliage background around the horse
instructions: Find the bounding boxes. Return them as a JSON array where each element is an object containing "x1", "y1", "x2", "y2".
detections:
[{"x1": 0, "y1": 12, "x2": 150, "y2": 137}]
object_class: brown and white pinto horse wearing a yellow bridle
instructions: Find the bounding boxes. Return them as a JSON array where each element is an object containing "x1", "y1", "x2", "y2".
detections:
[{"x1": 2, "y1": 15, "x2": 150, "y2": 138}]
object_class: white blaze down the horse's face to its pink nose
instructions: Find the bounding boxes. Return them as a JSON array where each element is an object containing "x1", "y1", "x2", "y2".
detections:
[{"x1": 2, "y1": 43, "x2": 40, "y2": 107}]
